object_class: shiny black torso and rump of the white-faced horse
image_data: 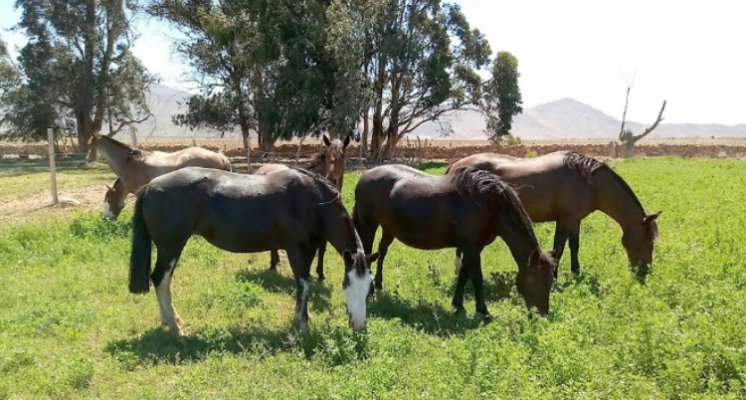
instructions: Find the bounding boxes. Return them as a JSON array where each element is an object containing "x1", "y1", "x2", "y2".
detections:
[{"x1": 144, "y1": 167, "x2": 319, "y2": 252}]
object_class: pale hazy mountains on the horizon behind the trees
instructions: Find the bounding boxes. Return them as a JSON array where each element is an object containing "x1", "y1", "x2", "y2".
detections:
[{"x1": 138, "y1": 85, "x2": 746, "y2": 140}]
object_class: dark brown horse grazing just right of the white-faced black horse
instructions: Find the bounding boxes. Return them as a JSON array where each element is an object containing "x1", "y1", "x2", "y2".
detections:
[{"x1": 352, "y1": 165, "x2": 555, "y2": 318}]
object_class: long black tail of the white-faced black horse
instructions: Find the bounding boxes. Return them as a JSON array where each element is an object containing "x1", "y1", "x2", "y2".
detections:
[{"x1": 130, "y1": 187, "x2": 152, "y2": 293}]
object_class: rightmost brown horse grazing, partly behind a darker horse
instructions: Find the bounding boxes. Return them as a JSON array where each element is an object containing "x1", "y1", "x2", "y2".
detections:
[{"x1": 446, "y1": 151, "x2": 660, "y2": 278}]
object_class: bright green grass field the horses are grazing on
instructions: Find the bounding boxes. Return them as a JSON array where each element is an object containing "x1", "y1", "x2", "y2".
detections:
[{"x1": 0, "y1": 158, "x2": 746, "y2": 399}]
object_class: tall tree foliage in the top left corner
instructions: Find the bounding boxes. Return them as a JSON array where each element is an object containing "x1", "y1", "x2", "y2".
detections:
[{"x1": 2, "y1": 0, "x2": 155, "y2": 149}]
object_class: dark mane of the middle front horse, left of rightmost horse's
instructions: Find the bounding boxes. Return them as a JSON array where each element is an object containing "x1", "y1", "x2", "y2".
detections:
[{"x1": 453, "y1": 166, "x2": 539, "y2": 245}]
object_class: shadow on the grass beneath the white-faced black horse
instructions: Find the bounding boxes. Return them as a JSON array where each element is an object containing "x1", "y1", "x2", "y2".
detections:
[{"x1": 105, "y1": 324, "x2": 368, "y2": 370}]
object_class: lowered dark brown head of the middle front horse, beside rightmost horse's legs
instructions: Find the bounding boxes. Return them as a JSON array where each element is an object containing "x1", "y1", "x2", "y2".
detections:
[{"x1": 516, "y1": 248, "x2": 557, "y2": 315}]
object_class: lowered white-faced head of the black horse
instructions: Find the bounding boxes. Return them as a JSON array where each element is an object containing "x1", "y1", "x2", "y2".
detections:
[{"x1": 342, "y1": 250, "x2": 378, "y2": 330}]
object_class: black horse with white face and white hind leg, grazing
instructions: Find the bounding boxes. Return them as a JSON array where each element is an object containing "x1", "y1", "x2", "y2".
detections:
[{"x1": 129, "y1": 167, "x2": 376, "y2": 334}]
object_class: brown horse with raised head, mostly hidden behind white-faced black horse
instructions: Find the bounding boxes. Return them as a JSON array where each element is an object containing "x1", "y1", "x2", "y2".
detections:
[{"x1": 254, "y1": 135, "x2": 350, "y2": 280}]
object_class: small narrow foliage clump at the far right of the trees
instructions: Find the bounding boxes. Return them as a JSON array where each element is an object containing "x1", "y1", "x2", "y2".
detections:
[{"x1": 482, "y1": 51, "x2": 523, "y2": 143}]
